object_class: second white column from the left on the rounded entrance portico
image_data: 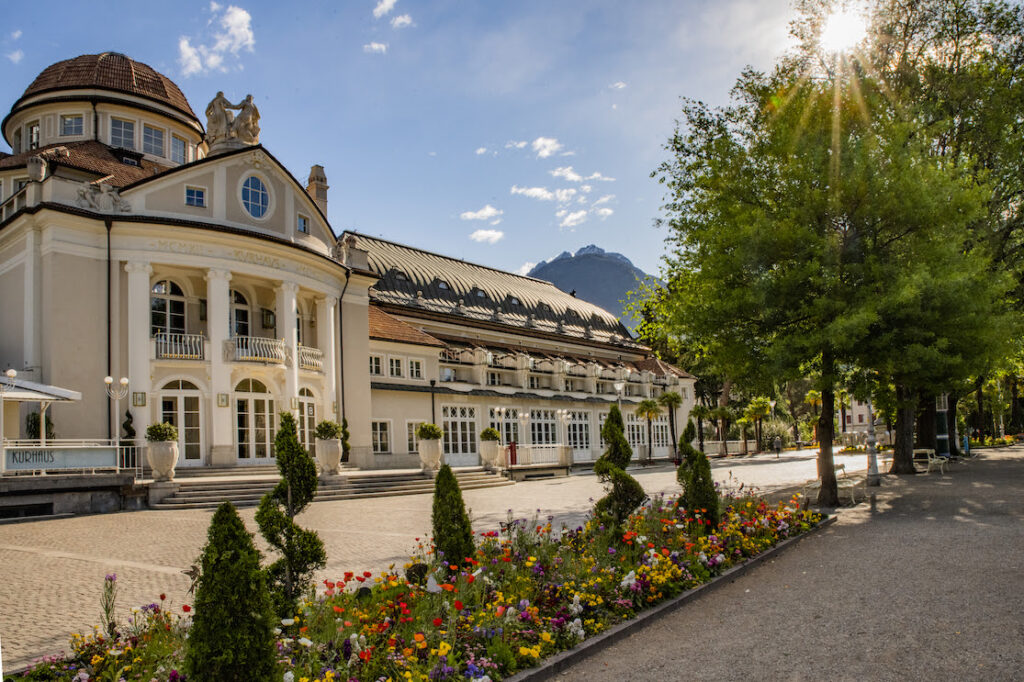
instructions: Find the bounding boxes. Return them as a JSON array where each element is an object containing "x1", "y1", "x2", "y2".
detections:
[{"x1": 206, "y1": 269, "x2": 236, "y2": 466}]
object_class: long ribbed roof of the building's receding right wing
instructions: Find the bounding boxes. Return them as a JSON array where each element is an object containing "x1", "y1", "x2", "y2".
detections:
[{"x1": 341, "y1": 232, "x2": 642, "y2": 348}]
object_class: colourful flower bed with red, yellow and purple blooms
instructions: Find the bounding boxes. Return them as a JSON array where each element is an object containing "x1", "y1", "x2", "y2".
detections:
[{"x1": 14, "y1": 497, "x2": 820, "y2": 682}]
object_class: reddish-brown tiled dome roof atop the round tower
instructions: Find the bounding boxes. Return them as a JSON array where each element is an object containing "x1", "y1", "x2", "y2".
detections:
[{"x1": 14, "y1": 52, "x2": 199, "y2": 123}]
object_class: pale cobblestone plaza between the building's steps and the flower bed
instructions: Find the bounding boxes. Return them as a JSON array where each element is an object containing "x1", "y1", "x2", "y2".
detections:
[{"x1": 0, "y1": 452, "x2": 865, "y2": 670}]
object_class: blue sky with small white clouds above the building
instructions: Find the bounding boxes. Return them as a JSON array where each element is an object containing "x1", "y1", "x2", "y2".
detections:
[{"x1": 0, "y1": 0, "x2": 793, "y2": 272}]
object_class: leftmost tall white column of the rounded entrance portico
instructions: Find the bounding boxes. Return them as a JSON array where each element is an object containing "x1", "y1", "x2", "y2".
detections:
[{"x1": 124, "y1": 261, "x2": 153, "y2": 445}]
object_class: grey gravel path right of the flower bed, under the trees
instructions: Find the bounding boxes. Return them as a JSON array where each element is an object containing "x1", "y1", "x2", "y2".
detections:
[{"x1": 557, "y1": 449, "x2": 1024, "y2": 682}]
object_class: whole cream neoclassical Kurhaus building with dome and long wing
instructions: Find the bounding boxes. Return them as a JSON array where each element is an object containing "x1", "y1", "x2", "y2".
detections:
[{"x1": 0, "y1": 52, "x2": 693, "y2": 467}]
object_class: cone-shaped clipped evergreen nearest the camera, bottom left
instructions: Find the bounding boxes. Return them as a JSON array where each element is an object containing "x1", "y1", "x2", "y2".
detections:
[{"x1": 185, "y1": 502, "x2": 280, "y2": 682}]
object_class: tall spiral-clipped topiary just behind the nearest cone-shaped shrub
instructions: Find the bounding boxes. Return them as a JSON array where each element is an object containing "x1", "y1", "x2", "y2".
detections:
[{"x1": 256, "y1": 412, "x2": 327, "y2": 616}]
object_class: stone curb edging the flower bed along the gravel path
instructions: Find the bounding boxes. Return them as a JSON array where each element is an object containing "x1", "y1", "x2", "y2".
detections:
[{"x1": 506, "y1": 514, "x2": 839, "y2": 682}]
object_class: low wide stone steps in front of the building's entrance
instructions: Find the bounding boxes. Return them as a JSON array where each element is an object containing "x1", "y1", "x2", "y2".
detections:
[{"x1": 153, "y1": 466, "x2": 514, "y2": 509}]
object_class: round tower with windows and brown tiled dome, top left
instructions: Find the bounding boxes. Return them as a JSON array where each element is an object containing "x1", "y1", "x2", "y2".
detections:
[{"x1": 2, "y1": 52, "x2": 204, "y2": 167}]
